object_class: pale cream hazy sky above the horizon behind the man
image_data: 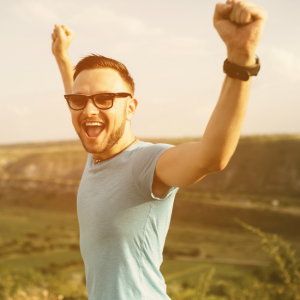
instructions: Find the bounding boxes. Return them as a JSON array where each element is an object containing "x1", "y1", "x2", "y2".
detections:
[{"x1": 0, "y1": 0, "x2": 300, "y2": 144}]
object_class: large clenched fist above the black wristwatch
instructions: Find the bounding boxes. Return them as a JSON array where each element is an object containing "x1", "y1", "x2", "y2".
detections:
[{"x1": 214, "y1": 0, "x2": 267, "y2": 66}]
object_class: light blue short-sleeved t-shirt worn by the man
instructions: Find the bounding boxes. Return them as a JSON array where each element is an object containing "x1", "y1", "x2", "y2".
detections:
[{"x1": 77, "y1": 142, "x2": 178, "y2": 300}]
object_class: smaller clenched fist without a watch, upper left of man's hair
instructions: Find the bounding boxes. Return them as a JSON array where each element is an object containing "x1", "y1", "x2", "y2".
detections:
[{"x1": 52, "y1": 24, "x2": 75, "y2": 56}]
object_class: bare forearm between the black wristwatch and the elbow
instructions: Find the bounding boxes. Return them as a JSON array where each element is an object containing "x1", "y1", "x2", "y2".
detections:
[{"x1": 198, "y1": 76, "x2": 251, "y2": 171}]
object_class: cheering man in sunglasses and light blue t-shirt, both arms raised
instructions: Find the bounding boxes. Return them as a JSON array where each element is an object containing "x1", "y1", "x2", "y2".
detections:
[{"x1": 52, "y1": 0, "x2": 267, "y2": 300}]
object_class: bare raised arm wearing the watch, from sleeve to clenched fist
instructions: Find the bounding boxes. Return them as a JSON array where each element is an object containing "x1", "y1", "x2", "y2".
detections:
[{"x1": 152, "y1": 0, "x2": 267, "y2": 197}]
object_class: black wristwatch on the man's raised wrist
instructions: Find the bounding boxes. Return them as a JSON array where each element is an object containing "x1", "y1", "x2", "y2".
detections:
[{"x1": 223, "y1": 55, "x2": 260, "y2": 81}]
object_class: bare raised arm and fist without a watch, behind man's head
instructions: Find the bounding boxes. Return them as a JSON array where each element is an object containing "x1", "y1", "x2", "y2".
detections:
[{"x1": 52, "y1": 24, "x2": 74, "y2": 94}]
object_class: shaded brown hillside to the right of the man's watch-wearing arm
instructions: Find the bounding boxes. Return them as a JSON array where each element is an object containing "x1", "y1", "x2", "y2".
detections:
[{"x1": 189, "y1": 136, "x2": 300, "y2": 197}]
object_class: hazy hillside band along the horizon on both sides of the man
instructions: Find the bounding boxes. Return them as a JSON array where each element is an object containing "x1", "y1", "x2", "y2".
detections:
[{"x1": 0, "y1": 135, "x2": 300, "y2": 199}]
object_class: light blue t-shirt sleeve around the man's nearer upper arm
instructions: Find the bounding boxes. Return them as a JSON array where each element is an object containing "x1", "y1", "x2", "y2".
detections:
[{"x1": 132, "y1": 144, "x2": 178, "y2": 200}]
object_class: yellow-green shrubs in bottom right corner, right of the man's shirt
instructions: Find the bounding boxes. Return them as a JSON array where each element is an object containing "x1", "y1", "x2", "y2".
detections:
[{"x1": 168, "y1": 220, "x2": 300, "y2": 300}]
